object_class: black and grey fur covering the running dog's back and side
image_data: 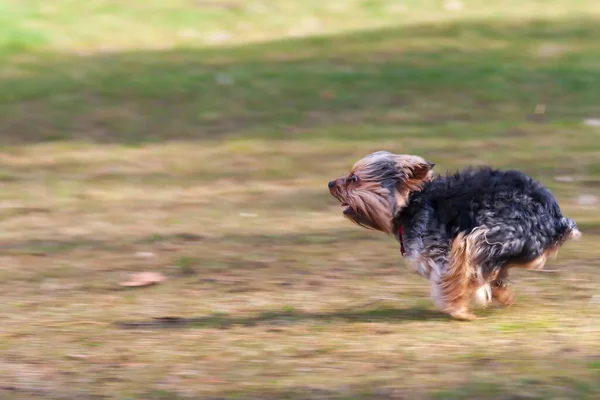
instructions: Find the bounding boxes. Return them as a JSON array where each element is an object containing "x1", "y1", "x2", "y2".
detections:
[{"x1": 393, "y1": 168, "x2": 577, "y2": 275}]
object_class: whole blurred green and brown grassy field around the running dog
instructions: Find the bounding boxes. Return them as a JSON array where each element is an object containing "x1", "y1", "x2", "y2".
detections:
[{"x1": 0, "y1": 0, "x2": 600, "y2": 400}]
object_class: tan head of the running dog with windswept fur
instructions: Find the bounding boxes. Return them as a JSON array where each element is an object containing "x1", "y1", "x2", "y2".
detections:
[{"x1": 329, "y1": 151, "x2": 435, "y2": 234}]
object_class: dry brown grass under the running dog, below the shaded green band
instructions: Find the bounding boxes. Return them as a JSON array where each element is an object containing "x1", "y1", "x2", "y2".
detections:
[{"x1": 0, "y1": 142, "x2": 600, "y2": 398}]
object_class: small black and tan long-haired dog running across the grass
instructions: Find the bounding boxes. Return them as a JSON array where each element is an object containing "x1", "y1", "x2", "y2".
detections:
[{"x1": 328, "y1": 151, "x2": 581, "y2": 320}]
